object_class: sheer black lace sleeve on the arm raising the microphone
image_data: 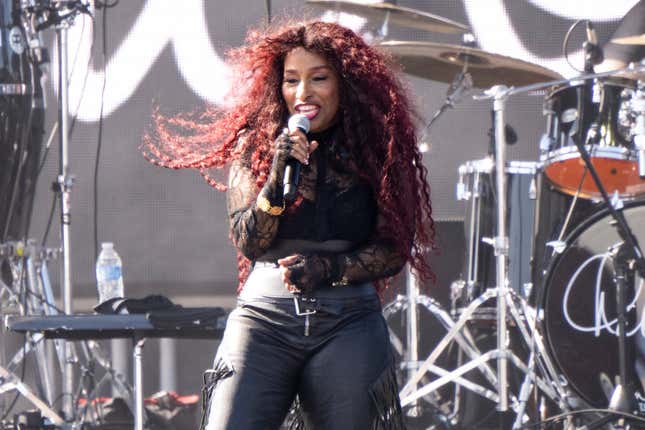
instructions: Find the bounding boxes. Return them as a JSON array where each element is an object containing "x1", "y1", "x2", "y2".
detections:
[{"x1": 226, "y1": 160, "x2": 280, "y2": 260}]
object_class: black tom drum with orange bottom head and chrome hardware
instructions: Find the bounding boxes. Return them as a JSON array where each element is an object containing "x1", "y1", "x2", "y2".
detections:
[{"x1": 540, "y1": 80, "x2": 645, "y2": 200}]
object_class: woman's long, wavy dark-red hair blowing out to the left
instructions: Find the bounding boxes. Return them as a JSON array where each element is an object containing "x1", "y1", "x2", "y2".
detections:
[{"x1": 144, "y1": 22, "x2": 434, "y2": 288}]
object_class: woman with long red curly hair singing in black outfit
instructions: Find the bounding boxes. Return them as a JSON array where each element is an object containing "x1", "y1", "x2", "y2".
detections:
[{"x1": 149, "y1": 22, "x2": 433, "y2": 430}]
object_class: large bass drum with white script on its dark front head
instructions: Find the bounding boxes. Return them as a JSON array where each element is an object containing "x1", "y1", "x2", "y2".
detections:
[{"x1": 540, "y1": 202, "x2": 645, "y2": 408}]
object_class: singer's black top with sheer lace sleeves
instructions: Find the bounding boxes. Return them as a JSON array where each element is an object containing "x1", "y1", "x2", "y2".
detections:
[{"x1": 227, "y1": 123, "x2": 405, "y2": 283}]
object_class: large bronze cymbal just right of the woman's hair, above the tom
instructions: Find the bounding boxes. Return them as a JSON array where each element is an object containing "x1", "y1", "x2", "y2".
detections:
[{"x1": 376, "y1": 40, "x2": 562, "y2": 88}]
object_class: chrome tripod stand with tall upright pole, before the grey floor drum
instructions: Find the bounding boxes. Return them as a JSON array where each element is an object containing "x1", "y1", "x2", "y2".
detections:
[{"x1": 400, "y1": 85, "x2": 566, "y2": 425}]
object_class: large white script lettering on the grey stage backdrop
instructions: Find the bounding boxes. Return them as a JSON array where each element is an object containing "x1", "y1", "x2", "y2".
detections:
[{"x1": 50, "y1": 0, "x2": 635, "y2": 122}]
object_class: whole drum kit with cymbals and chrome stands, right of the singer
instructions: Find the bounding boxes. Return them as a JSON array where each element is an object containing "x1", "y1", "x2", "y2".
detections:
[{"x1": 307, "y1": 0, "x2": 645, "y2": 429}]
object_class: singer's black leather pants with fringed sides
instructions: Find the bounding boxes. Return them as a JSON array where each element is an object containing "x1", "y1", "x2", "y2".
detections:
[{"x1": 205, "y1": 294, "x2": 403, "y2": 430}]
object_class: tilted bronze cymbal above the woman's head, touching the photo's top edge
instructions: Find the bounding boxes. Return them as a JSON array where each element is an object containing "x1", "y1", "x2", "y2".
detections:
[{"x1": 307, "y1": 0, "x2": 470, "y2": 34}]
